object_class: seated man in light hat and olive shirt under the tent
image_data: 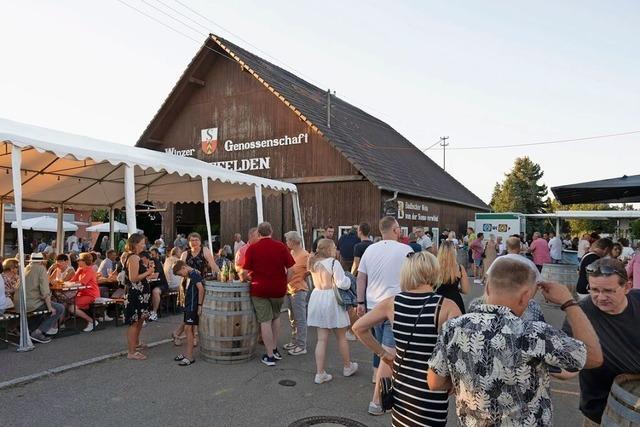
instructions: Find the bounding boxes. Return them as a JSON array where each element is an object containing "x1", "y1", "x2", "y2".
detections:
[{"x1": 13, "y1": 252, "x2": 64, "y2": 343}]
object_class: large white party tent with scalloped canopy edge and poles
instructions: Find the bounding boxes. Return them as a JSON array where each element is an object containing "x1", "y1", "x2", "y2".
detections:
[{"x1": 0, "y1": 119, "x2": 302, "y2": 351}]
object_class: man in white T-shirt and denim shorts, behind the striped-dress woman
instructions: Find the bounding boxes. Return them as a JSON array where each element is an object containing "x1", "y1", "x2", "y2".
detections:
[{"x1": 357, "y1": 216, "x2": 413, "y2": 415}]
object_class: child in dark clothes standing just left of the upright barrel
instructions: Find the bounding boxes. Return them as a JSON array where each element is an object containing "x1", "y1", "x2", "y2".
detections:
[{"x1": 173, "y1": 260, "x2": 204, "y2": 366}]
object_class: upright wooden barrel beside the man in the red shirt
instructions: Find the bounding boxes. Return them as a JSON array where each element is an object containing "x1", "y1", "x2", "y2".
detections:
[{"x1": 199, "y1": 281, "x2": 258, "y2": 364}]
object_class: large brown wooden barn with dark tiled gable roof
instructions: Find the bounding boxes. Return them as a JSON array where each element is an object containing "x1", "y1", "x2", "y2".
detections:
[{"x1": 137, "y1": 35, "x2": 489, "y2": 244}]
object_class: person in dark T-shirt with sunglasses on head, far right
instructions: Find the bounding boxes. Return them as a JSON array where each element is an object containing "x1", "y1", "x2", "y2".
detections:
[{"x1": 563, "y1": 258, "x2": 640, "y2": 426}]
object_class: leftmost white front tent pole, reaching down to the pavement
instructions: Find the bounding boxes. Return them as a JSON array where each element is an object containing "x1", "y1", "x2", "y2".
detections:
[{"x1": 11, "y1": 145, "x2": 33, "y2": 351}]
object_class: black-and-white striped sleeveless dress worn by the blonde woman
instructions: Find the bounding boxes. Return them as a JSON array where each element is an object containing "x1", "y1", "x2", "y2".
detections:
[{"x1": 392, "y1": 292, "x2": 449, "y2": 427}]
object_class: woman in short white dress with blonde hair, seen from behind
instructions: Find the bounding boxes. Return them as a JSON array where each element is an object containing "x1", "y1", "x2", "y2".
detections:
[{"x1": 307, "y1": 239, "x2": 358, "y2": 384}]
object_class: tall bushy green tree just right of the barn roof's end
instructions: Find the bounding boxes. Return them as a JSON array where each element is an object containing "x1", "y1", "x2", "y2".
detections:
[{"x1": 491, "y1": 156, "x2": 549, "y2": 214}]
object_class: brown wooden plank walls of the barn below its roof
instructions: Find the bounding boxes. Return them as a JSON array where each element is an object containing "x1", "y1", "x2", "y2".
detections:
[{"x1": 138, "y1": 36, "x2": 488, "y2": 244}]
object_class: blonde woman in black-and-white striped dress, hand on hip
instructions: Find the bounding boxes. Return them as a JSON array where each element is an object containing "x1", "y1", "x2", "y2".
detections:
[{"x1": 353, "y1": 251, "x2": 461, "y2": 427}]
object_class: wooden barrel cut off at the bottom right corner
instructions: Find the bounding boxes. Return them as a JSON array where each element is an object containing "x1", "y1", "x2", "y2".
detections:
[{"x1": 601, "y1": 374, "x2": 640, "y2": 427}]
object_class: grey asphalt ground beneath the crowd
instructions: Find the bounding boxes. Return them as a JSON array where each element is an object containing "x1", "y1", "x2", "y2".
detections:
[{"x1": 0, "y1": 285, "x2": 582, "y2": 426}]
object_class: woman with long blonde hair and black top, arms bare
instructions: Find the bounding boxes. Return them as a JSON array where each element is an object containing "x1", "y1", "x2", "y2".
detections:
[{"x1": 436, "y1": 241, "x2": 471, "y2": 314}]
